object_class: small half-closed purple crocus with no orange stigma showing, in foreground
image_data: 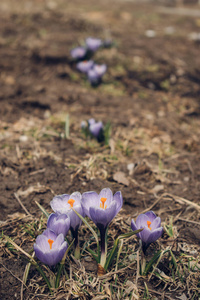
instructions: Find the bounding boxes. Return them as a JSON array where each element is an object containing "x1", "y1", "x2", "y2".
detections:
[{"x1": 47, "y1": 213, "x2": 70, "y2": 236}]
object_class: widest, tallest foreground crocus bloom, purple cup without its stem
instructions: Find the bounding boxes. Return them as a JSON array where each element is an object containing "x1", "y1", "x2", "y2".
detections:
[{"x1": 82, "y1": 188, "x2": 123, "y2": 228}]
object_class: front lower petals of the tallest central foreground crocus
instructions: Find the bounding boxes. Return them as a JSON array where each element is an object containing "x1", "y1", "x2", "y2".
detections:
[{"x1": 89, "y1": 201, "x2": 117, "y2": 227}]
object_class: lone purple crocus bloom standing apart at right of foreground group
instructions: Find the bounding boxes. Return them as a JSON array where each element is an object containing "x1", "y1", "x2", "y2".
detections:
[{"x1": 131, "y1": 211, "x2": 163, "y2": 253}]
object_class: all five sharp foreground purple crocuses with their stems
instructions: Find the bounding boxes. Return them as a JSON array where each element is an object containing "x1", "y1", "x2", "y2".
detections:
[{"x1": 34, "y1": 188, "x2": 163, "y2": 271}]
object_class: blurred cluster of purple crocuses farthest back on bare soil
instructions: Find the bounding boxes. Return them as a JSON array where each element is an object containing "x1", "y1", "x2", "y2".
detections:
[{"x1": 71, "y1": 37, "x2": 108, "y2": 86}]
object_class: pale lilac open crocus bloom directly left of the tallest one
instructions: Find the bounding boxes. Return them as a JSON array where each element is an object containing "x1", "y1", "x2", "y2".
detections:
[{"x1": 50, "y1": 192, "x2": 84, "y2": 231}]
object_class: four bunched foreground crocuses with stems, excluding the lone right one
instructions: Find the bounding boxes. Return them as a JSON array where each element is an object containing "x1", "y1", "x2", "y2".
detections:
[{"x1": 34, "y1": 188, "x2": 123, "y2": 266}]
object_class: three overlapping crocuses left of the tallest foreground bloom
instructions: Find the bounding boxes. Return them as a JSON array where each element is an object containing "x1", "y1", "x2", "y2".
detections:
[{"x1": 34, "y1": 192, "x2": 84, "y2": 266}]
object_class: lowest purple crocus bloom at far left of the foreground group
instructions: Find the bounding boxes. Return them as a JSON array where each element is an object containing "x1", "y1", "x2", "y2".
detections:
[{"x1": 33, "y1": 228, "x2": 68, "y2": 266}]
